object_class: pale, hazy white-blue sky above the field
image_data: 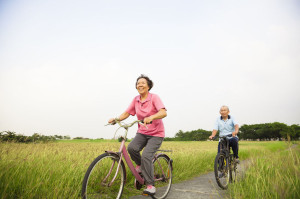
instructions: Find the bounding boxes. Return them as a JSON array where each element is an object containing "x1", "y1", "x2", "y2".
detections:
[{"x1": 0, "y1": 0, "x2": 300, "y2": 139}]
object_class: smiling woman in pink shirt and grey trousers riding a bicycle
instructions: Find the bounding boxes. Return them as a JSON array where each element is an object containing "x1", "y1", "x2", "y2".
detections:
[{"x1": 108, "y1": 75, "x2": 167, "y2": 195}]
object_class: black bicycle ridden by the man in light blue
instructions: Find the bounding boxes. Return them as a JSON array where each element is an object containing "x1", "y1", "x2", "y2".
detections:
[{"x1": 214, "y1": 135, "x2": 237, "y2": 189}]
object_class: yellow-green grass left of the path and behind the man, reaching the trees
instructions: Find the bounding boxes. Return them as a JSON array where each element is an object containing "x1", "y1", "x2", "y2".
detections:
[{"x1": 0, "y1": 142, "x2": 292, "y2": 199}]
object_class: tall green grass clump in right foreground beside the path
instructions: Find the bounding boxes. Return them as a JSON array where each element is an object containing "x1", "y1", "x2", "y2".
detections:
[{"x1": 230, "y1": 142, "x2": 300, "y2": 199}]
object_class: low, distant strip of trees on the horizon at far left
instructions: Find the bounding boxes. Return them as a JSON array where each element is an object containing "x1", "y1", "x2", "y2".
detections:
[{"x1": 0, "y1": 131, "x2": 71, "y2": 143}]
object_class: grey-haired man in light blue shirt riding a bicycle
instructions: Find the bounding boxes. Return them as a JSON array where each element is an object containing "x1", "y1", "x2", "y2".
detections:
[{"x1": 209, "y1": 106, "x2": 240, "y2": 163}]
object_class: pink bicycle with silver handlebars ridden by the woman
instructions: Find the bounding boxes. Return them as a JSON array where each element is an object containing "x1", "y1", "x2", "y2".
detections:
[{"x1": 81, "y1": 119, "x2": 173, "y2": 199}]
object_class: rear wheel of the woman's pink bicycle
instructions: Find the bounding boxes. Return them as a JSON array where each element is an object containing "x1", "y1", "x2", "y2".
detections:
[{"x1": 153, "y1": 154, "x2": 173, "y2": 199}]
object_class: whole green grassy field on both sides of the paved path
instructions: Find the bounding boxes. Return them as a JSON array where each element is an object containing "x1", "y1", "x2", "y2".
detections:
[{"x1": 0, "y1": 141, "x2": 300, "y2": 199}]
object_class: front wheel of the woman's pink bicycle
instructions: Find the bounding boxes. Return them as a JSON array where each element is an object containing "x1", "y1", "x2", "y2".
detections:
[{"x1": 81, "y1": 153, "x2": 126, "y2": 199}]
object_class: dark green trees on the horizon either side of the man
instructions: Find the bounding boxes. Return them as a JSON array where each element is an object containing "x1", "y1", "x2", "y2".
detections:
[{"x1": 165, "y1": 122, "x2": 300, "y2": 141}]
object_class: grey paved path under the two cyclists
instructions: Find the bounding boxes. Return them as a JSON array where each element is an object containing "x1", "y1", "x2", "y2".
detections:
[{"x1": 130, "y1": 161, "x2": 249, "y2": 199}]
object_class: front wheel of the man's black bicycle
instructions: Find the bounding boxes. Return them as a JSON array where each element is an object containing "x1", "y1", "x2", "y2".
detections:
[{"x1": 214, "y1": 153, "x2": 230, "y2": 189}]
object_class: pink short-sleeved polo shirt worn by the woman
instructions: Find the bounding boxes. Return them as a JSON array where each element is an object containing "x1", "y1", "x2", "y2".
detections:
[{"x1": 126, "y1": 93, "x2": 165, "y2": 137}]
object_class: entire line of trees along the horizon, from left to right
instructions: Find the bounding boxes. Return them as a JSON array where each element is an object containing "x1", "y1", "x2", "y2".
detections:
[{"x1": 0, "y1": 122, "x2": 300, "y2": 143}]
